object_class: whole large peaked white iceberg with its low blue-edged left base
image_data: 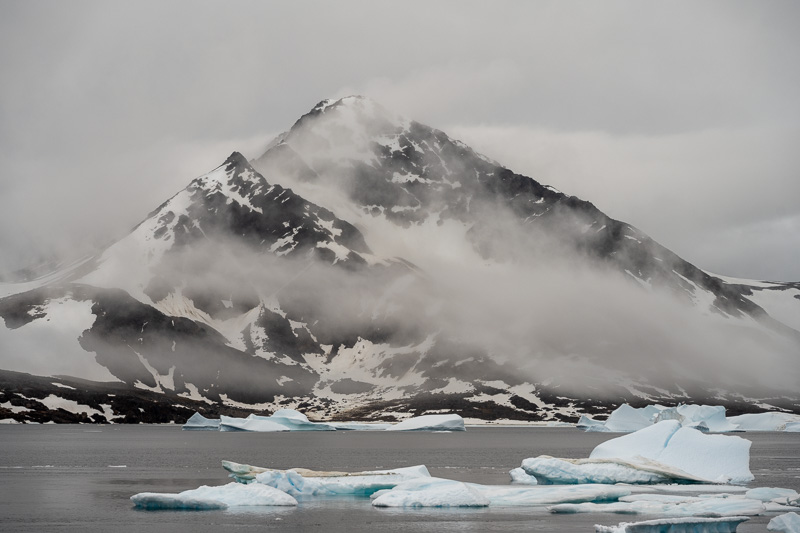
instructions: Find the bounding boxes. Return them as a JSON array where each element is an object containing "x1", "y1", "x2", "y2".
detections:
[{"x1": 522, "y1": 420, "x2": 754, "y2": 484}]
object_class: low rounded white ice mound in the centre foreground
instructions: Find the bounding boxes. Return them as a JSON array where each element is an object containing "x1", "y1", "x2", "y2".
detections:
[{"x1": 372, "y1": 478, "x2": 489, "y2": 507}]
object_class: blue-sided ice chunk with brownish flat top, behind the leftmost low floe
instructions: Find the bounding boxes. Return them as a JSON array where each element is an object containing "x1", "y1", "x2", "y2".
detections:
[{"x1": 255, "y1": 465, "x2": 430, "y2": 496}]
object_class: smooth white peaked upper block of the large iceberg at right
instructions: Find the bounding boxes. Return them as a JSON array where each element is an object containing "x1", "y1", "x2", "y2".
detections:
[{"x1": 589, "y1": 420, "x2": 755, "y2": 484}]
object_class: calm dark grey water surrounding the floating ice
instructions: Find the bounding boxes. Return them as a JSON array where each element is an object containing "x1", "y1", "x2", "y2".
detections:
[{"x1": 0, "y1": 425, "x2": 800, "y2": 533}]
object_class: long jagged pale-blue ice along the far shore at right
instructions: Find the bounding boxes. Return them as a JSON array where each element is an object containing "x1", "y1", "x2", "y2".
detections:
[{"x1": 578, "y1": 404, "x2": 800, "y2": 433}]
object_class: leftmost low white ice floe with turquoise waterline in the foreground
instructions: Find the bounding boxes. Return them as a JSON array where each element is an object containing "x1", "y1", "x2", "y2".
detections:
[{"x1": 131, "y1": 483, "x2": 297, "y2": 510}]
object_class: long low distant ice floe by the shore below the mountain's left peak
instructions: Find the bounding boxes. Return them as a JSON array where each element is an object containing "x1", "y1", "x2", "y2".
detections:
[{"x1": 183, "y1": 409, "x2": 465, "y2": 433}]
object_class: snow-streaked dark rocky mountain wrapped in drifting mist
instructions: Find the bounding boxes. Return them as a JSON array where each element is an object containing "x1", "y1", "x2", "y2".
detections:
[{"x1": 0, "y1": 97, "x2": 800, "y2": 421}]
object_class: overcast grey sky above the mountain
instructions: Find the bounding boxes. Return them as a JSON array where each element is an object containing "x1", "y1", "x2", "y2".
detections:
[{"x1": 0, "y1": 0, "x2": 800, "y2": 280}]
